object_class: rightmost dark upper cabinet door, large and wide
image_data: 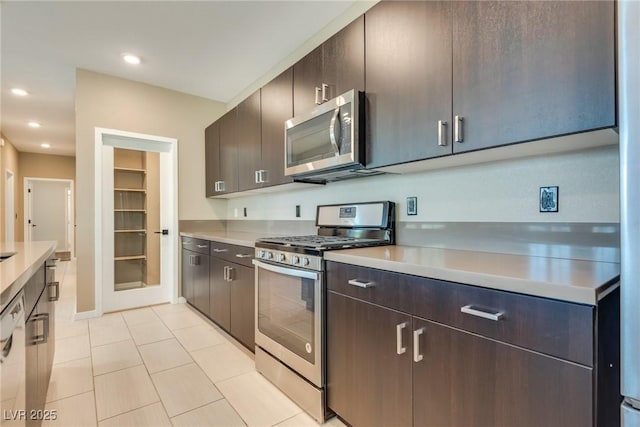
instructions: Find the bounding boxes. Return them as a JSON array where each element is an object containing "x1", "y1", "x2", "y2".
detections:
[{"x1": 452, "y1": 1, "x2": 616, "y2": 152}]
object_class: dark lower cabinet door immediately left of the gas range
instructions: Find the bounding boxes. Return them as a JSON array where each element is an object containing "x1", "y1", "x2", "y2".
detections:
[{"x1": 228, "y1": 263, "x2": 255, "y2": 351}]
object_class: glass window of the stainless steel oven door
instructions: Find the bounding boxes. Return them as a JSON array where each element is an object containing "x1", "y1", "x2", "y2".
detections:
[{"x1": 258, "y1": 269, "x2": 317, "y2": 363}]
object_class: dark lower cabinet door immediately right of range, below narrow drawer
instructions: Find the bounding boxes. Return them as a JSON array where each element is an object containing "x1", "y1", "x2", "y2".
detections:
[{"x1": 327, "y1": 291, "x2": 412, "y2": 427}]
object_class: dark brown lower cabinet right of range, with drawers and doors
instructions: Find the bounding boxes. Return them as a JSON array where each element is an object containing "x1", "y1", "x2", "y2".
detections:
[{"x1": 327, "y1": 261, "x2": 620, "y2": 427}]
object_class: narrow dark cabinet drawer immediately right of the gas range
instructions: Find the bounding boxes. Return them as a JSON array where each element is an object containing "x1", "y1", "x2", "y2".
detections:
[{"x1": 326, "y1": 261, "x2": 412, "y2": 313}]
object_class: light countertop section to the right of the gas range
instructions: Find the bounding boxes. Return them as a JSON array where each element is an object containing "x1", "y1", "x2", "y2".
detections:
[{"x1": 325, "y1": 246, "x2": 620, "y2": 305}]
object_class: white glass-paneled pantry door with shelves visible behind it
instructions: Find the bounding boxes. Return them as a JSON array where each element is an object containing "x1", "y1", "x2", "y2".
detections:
[{"x1": 96, "y1": 129, "x2": 178, "y2": 313}]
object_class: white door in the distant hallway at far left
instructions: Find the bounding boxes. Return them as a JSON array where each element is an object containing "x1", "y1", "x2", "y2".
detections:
[{"x1": 25, "y1": 178, "x2": 71, "y2": 251}]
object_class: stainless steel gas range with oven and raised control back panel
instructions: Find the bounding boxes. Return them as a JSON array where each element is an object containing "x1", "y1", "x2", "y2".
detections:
[{"x1": 253, "y1": 202, "x2": 395, "y2": 422}]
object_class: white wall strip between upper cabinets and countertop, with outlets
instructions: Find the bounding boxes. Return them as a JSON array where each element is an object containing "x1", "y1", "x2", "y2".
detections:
[{"x1": 227, "y1": 146, "x2": 620, "y2": 223}]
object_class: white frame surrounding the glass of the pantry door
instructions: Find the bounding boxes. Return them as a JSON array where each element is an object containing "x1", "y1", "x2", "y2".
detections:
[{"x1": 94, "y1": 127, "x2": 179, "y2": 316}]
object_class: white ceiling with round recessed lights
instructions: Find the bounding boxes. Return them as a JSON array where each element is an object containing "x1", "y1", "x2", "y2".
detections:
[{"x1": 0, "y1": 0, "x2": 355, "y2": 155}]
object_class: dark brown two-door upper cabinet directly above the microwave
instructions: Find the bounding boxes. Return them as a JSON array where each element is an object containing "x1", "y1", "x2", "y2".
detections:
[{"x1": 293, "y1": 16, "x2": 364, "y2": 116}]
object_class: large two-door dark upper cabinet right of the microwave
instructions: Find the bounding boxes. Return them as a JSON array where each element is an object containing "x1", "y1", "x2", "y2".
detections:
[{"x1": 366, "y1": 1, "x2": 616, "y2": 167}]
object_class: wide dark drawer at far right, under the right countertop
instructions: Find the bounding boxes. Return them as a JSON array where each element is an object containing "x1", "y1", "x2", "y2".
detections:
[{"x1": 412, "y1": 279, "x2": 594, "y2": 366}]
